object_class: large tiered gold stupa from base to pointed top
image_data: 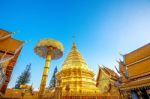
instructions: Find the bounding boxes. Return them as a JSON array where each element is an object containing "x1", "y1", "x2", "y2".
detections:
[{"x1": 56, "y1": 42, "x2": 99, "y2": 96}]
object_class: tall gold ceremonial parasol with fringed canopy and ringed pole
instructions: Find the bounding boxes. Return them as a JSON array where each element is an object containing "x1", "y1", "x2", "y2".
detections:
[{"x1": 35, "y1": 39, "x2": 64, "y2": 99}]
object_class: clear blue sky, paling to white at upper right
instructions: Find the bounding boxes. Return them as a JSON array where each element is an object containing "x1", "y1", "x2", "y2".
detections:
[{"x1": 0, "y1": 0, "x2": 150, "y2": 89}]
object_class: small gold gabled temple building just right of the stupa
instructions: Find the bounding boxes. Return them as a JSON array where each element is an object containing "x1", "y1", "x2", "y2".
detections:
[{"x1": 96, "y1": 66, "x2": 119, "y2": 96}]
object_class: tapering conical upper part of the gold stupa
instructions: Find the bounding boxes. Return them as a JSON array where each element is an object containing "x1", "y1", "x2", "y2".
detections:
[{"x1": 62, "y1": 42, "x2": 88, "y2": 69}]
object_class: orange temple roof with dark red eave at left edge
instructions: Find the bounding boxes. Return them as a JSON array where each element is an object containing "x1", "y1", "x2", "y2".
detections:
[{"x1": 0, "y1": 29, "x2": 23, "y2": 93}]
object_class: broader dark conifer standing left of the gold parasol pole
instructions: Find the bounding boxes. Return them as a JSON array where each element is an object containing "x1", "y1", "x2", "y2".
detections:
[{"x1": 15, "y1": 64, "x2": 31, "y2": 89}]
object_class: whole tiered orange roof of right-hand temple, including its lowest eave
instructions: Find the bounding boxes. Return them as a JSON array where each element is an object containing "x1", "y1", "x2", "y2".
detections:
[{"x1": 119, "y1": 43, "x2": 150, "y2": 91}]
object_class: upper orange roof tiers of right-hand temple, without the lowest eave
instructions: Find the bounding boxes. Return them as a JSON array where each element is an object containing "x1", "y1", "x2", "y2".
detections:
[{"x1": 119, "y1": 43, "x2": 150, "y2": 82}]
